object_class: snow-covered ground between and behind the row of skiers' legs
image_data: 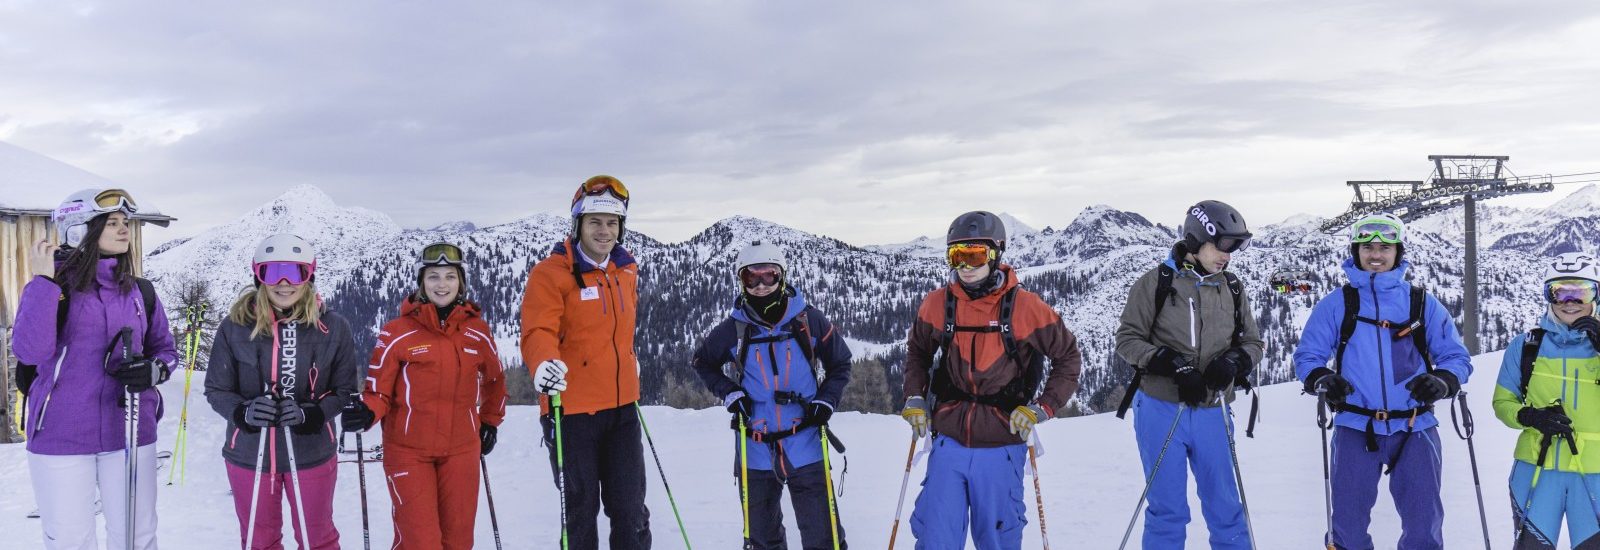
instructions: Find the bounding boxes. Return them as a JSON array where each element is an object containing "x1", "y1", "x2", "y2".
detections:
[{"x1": 0, "y1": 352, "x2": 1515, "y2": 548}]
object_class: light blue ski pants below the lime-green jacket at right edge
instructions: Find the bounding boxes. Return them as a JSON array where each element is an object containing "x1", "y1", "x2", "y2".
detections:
[{"x1": 1510, "y1": 460, "x2": 1600, "y2": 548}]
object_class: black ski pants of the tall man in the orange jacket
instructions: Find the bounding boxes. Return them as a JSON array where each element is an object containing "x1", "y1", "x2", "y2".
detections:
[{"x1": 539, "y1": 403, "x2": 650, "y2": 550}]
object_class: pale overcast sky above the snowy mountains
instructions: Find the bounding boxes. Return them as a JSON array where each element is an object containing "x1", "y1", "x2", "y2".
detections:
[{"x1": 0, "y1": 0, "x2": 1600, "y2": 243}]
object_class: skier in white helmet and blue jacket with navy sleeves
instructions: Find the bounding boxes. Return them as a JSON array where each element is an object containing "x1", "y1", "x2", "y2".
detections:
[{"x1": 694, "y1": 241, "x2": 850, "y2": 550}]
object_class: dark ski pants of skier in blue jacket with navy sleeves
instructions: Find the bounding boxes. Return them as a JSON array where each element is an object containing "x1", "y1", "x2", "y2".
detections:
[{"x1": 734, "y1": 462, "x2": 848, "y2": 550}]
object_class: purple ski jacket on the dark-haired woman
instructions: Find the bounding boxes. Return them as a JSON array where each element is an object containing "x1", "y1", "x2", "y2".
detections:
[{"x1": 11, "y1": 259, "x2": 178, "y2": 454}]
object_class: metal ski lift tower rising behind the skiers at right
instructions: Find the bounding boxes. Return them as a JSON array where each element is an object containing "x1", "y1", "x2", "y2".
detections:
[{"x1": 1320, "y1": 155, "x2": 1555, "y2": 355}]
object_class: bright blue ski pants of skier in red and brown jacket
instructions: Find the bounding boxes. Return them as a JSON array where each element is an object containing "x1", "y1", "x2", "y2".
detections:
[{"x1": 910, "y1": 436, "x2": 1027, "y2": 550}]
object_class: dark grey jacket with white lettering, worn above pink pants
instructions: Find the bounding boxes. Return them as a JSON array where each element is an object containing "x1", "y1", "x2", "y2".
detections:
[{"x1": 205, "y1": 306, "x2": 366, "y2": 472}]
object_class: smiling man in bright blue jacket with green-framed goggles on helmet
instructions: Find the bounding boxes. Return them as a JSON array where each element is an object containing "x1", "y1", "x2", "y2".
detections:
[{"x1": 1294, "y1": 214, "x2": 1472, "y2": 550}]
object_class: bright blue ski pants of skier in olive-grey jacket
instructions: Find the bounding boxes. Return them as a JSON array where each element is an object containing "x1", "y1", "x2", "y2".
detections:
[{"x1": 1133, "y1": 392, "x2": 1250, "y2": 550}]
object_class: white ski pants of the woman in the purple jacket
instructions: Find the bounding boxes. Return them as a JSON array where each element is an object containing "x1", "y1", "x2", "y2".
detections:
[{"x1": 27, "y1": 443, "x2": 155, "y2": 550}]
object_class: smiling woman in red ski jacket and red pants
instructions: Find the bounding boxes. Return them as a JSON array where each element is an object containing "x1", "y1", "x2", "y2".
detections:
[{"x1": 344, "y1": 243, "x2": 506, "y2": 550}]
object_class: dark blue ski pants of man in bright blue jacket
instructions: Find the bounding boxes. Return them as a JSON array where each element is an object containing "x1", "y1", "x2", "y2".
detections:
[{"x1": 1330, "y1": 425, "x2": 1445, "y2": 550}]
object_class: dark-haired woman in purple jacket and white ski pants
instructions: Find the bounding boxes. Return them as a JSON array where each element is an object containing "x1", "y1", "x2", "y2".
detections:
[{"x1": 11, "y1": 189, "x2": 178, "y2": 550}]
